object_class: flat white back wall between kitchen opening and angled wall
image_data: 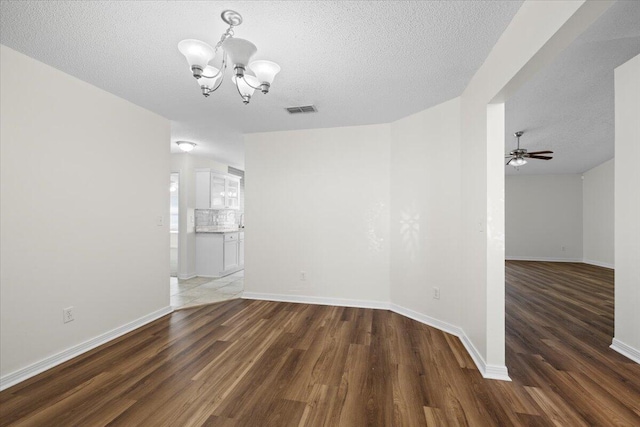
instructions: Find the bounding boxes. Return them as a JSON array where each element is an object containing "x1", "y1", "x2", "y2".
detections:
[{"x1": 245, "y1": 125, "x2": 390, "y2": 304}]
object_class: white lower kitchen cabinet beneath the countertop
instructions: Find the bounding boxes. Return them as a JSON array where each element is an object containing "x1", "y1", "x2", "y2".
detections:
[{"x1": 196, "y1": 232, "x2": 244, "y2": 277}]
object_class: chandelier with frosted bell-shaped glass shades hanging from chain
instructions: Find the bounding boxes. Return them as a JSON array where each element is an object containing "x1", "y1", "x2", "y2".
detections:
[{"x1": 178, "y1": 10, "x2": 280, "y2": 104}]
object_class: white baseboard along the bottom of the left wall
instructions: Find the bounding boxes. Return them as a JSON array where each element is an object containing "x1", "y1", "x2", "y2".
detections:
[{"x1": 0, "y1": 307, "x2": 173, "y2": 391}]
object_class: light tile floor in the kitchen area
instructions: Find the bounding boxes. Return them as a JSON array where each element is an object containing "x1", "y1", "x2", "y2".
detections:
[{"x1": 170, "y1": 270, "x2": 244, "y2": 309}]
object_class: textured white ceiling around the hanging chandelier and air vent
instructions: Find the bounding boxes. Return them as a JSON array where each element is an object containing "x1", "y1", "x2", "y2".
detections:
[{"x1": 0, "y1": 1, "x2": 524, "y2": 168}]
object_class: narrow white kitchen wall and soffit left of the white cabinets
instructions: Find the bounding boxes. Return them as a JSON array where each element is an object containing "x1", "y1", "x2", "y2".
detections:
[{"x1": 171, "y1": 152, "x2": 229, "y2": 279}]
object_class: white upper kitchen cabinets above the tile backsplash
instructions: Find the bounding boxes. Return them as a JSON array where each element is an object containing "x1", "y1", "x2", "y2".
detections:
[{"x1": 196, "y1": 169, "x2": 240, "y2": 209}]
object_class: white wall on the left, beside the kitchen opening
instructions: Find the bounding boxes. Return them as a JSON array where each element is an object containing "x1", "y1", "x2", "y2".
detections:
[{"x1": 0, "y1": 46, "x2": 170, "y2": 383}]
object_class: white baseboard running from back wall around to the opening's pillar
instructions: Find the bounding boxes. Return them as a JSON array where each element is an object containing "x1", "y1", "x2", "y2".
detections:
[{"x1": 242, "y1": 292, "x2": 511, "y2": 381}]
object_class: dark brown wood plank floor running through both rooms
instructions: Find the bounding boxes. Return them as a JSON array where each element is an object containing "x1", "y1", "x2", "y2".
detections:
[{"x1": 0, "y1": 262, "x2": 640, "y2": 426}]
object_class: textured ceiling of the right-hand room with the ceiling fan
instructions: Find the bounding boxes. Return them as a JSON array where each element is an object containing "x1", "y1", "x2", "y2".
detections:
[{"x1": 505, "y1": 1, "x2": 640, "y2": 175}]
